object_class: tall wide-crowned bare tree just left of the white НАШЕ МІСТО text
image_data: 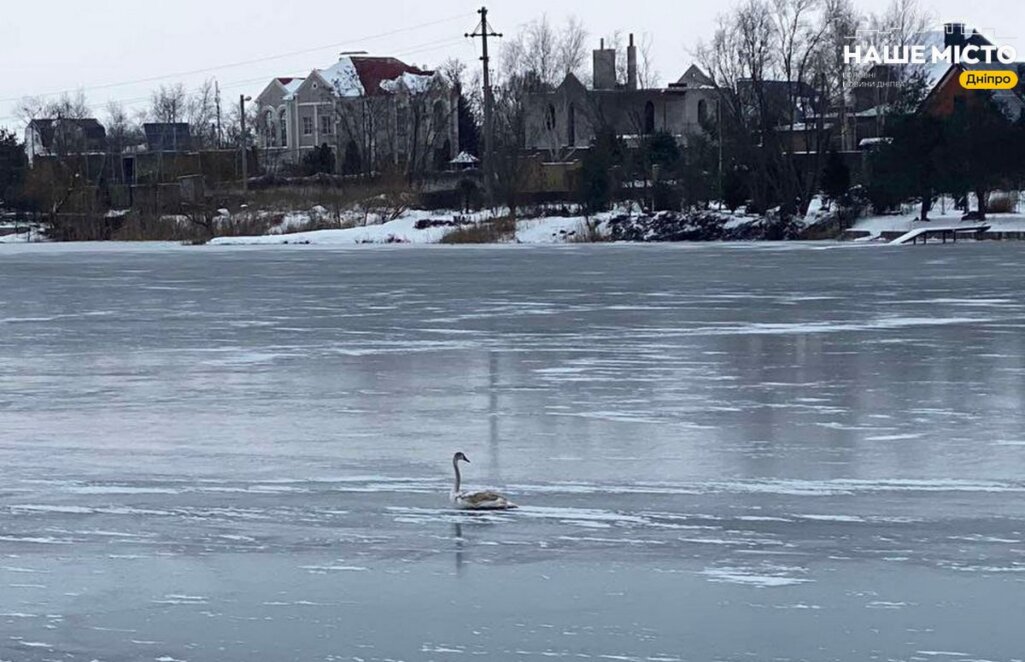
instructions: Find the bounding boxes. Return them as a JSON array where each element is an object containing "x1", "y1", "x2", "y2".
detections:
[{"x1": 698, "y1": 0, "x2": 853, "y2": 220}]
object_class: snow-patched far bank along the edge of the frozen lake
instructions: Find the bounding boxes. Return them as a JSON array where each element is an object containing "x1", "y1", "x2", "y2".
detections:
[{"x1": 12, "y1": 206, "x2": 1025, "y2": 246}]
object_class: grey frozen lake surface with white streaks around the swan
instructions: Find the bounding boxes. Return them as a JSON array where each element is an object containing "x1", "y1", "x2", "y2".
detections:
[{"x1": 0, "y1": 243, "x2": 1025, "y2": 662}]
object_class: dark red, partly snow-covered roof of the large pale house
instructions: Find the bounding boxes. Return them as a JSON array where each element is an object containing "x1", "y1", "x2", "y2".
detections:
[{"x1": 317, "y1": 55, "x2": 435, "y2": 96}]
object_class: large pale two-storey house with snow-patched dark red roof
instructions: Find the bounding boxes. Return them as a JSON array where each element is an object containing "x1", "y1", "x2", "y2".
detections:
[{"x1": 256, "y1": 54, "x2": 459, "y2": 174}]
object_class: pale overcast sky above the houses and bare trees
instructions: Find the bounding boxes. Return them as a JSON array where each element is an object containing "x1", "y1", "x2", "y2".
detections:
[{"x1": 0, "y1": 0, "x2": 1025, "y2": 126}]
